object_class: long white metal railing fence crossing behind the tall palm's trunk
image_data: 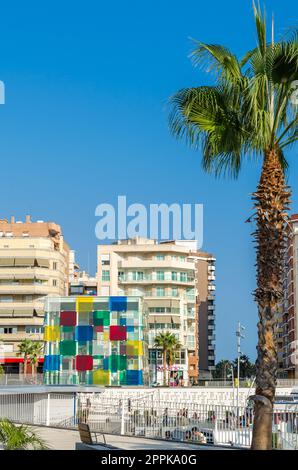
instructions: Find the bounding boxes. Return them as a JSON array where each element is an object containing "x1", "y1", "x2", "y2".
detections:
[{"x1": 0, "y1": 390, "x2": 298, "y2": 449}]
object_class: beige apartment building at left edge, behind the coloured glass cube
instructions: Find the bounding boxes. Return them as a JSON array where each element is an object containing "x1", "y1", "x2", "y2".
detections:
[{"x1": 0, "y1": 216, "x2": 69, "y2": 372}]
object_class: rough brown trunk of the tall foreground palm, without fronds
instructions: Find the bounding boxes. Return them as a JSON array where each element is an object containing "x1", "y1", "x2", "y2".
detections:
[{"x1": 252, "y1": 148, "x2": 290, "y2": 450}]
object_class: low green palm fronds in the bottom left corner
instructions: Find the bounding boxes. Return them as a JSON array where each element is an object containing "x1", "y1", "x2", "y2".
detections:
[{"x1": 0, "y1": 419, "x2": 48, "y2": 450}]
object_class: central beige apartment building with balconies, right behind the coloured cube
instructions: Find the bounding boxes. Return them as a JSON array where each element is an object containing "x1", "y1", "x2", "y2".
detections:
[{"x1": 97, "y1": 238, "x2": 215, "y2": 385}]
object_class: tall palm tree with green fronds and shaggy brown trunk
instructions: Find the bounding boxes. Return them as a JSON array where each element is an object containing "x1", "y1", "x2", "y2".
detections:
[{"x1": 170, "y1": 5, "x2": 298, "y2": 449}]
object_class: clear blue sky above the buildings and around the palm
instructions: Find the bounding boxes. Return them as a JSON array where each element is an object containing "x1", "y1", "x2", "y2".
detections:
[{"x1": 0, "y1": 0, "x2": 298, "y2": 359}]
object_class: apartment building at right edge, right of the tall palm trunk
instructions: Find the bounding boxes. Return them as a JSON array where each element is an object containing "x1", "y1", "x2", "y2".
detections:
[{"x1": 276, "y1": 214, "x2": 298, "y2": 378}]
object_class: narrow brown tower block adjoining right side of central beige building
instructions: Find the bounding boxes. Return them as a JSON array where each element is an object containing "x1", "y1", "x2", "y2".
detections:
[{"x1": 195, "y1": 252, "x2": 216, "y2": 379}]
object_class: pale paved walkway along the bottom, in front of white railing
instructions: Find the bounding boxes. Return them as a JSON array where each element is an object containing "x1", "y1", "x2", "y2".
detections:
[{"x1": 34, "y1": 426, "x2": 228, "y2": 450}]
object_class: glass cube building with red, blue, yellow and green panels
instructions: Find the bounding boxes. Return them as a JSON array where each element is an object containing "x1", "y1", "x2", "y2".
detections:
[{"x1": 44, "y1": 296, "x2": 148, "y2": 386}]
